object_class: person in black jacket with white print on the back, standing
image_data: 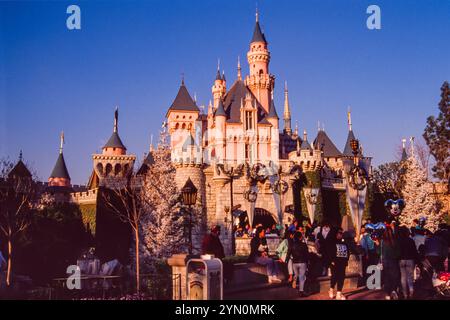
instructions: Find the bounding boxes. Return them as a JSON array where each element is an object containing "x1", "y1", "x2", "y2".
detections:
[{"x1": 328, "y1": 228, "x2": 350, "y2": 300}]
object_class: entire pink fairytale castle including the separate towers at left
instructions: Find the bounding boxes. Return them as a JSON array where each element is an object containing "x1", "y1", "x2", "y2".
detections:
[{"x1": 7, "y1": 14, "x2": 371, "y2": 253}]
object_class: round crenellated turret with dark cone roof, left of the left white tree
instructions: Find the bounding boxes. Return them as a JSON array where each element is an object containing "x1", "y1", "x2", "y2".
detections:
[{"x1": 90, "y1": 108, "x2": 136, "y2": 189}]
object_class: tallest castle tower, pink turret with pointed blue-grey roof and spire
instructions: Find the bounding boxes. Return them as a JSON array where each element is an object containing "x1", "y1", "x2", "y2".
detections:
[{"x1": 245, "y1": 12, "x2": 275, "y2": 113}]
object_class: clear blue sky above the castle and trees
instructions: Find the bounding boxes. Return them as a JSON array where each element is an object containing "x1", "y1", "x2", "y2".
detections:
[{"x1": 0, "y1": 0, "x2": 450, "y2": 183}]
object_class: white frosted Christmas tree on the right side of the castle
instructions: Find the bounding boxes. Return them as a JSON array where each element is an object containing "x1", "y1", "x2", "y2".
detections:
[{"x1": 400, "y1": 139, "x2": 442, "y2": 231}]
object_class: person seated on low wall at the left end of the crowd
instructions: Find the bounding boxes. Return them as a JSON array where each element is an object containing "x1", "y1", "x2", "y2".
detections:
[{"x1": 248, "y1": 226, "x2": 281, "y2": 283}]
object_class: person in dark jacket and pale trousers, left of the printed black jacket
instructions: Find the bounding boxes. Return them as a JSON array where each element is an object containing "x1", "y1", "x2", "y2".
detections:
[{"x1": 286, "y1": 231, "x2": 309, "y2": 297}]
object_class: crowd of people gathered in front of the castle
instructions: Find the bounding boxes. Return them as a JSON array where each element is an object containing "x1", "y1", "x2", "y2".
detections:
[{"x1": 203, "y1": 215, "x2": 450, "y2": 300}]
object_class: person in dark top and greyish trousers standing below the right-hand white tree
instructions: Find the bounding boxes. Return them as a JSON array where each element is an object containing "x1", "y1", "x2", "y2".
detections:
[{"x1": 398, "y1": 227, "x2": 419, "y2": 299}]
